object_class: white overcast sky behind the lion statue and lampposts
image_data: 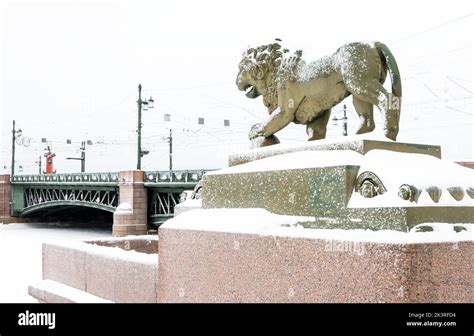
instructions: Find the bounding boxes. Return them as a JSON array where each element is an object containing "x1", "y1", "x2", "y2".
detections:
[{"x1": 0, "y1": 0, "x2": 474, "y2": 173}]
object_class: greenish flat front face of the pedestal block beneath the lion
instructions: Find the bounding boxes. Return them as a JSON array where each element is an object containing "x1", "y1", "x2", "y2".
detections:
[{"x1": 202, "y1": 166, "x2": 358, "y2": 216}]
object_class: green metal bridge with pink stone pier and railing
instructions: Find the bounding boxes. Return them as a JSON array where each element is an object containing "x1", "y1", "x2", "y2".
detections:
[{"x1": 4, "y1": 170, "x2": 206, "y2": 235}]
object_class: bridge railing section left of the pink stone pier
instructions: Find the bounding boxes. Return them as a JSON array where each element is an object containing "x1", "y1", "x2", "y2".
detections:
[{"x1": 12, "y1": 172, "x2": 119, "y2": 184}]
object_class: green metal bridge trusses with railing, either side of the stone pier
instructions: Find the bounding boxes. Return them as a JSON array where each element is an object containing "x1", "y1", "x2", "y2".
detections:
[{"x1": 12, "y1": 170, "x2": 206, "y2": 224}]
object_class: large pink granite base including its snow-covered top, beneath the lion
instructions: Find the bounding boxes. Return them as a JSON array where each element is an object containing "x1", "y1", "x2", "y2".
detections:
[{"x1": 157, "y1": 209, "x2": 474, "y2": 303}]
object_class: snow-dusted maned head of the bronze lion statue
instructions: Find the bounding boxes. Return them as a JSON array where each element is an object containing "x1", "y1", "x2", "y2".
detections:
[{"x1": 236, "y1": 43, "x2": 301, "y2": 113}]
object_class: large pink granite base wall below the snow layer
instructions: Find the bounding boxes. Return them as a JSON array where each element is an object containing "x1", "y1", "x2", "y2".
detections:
[{"x1": 157, "y1": 227, "x2": 474, "y2": 303}]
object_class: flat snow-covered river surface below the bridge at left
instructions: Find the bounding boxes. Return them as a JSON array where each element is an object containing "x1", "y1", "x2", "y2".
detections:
[{"x1": 0, "y1": 223, "x2": 112, "y2": 303}]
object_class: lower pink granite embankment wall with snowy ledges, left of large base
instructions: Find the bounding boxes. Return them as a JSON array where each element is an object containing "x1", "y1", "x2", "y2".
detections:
[{"x1": 29, "y1": 235, "x2": 158, "y2": 303}]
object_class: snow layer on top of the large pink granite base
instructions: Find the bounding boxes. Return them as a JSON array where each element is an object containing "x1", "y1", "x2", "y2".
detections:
[{"x1": 166, "y1": 208, "x2": 474, "y2": 244}]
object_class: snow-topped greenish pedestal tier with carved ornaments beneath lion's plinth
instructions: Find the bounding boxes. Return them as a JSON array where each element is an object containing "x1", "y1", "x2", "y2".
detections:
[{"x1": 202, "y1": 148, "x2": 474, "y2": 231}]
